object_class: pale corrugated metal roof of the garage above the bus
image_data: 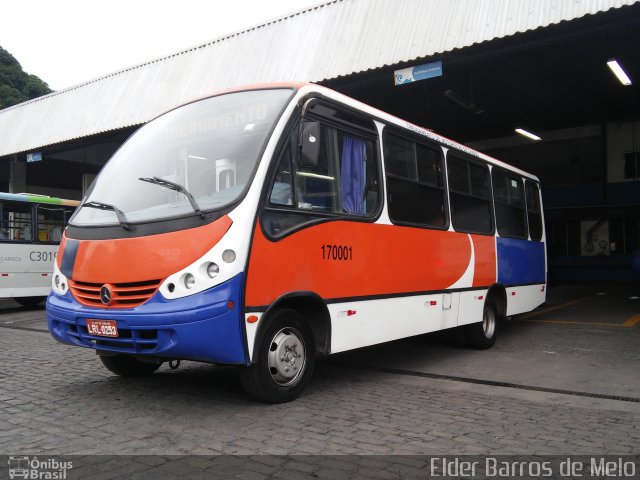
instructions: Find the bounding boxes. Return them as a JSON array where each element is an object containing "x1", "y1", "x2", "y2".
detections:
[{"x1": 0, "y1": 0, "x2": 639, "y2": 156}]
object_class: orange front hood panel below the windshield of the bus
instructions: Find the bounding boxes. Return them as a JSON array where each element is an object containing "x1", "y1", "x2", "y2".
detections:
[{"x1": 67, "y1": 216, "x2": 232, "y2": 283}]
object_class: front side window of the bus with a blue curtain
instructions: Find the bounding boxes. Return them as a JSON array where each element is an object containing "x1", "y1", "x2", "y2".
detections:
[{"x1": 269, "y1": 125, "x2": 379, "y2": 216}]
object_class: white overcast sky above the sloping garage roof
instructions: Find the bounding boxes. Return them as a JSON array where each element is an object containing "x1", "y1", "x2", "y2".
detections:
[{"x1": 0, "y1": 0, "x2": 325, "y2": 90}]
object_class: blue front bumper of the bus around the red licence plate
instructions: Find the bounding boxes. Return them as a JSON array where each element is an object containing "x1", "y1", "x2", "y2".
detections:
[{"x1": 47, "y1": 274, "x2": 249, "y2": 365}]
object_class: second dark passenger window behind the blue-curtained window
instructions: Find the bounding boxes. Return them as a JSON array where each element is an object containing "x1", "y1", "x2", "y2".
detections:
[{"x1": 447, "y1": 154, "x2": 493, "y2": 234}]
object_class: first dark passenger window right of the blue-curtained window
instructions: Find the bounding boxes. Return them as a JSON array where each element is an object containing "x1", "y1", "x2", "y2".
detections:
[{"x1": 384, "y1": 133, "x2": 447, "y2": 228}]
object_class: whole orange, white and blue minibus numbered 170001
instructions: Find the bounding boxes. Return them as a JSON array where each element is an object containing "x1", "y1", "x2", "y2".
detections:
[{"x1": 47, "y1": 84, "x2": 546, "y2": 402}]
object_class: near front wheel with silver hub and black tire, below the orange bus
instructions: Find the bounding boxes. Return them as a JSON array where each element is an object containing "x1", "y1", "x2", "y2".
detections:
[{"x1": 240, "y1": 309, "x2": 315, "y2": 403}]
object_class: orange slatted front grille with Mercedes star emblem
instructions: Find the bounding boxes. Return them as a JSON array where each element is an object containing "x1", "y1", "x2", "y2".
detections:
[{"x1": 69, "y1": 280, "x2": 162, "y2": 308}]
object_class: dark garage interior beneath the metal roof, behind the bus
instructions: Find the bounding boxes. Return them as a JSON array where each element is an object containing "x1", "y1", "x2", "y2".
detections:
[{"x1": 0, "y1": 3, "x2": 640, "y2": 283}]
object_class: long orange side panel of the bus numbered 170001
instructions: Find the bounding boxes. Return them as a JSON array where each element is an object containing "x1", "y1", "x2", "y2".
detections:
[{"x1": 245, "y1": 221, "x2": 480, "y2": 306}]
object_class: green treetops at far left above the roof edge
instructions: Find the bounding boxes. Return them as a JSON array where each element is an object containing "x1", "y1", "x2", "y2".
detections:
[{"x1": 0, "y1": 47, "x2": 51, "y2": 110}]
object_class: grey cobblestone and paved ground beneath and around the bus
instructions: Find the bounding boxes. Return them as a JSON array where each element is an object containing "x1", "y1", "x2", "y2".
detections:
[{"x1": 0, "y1": 290, "x2": 640, "y2": 480}]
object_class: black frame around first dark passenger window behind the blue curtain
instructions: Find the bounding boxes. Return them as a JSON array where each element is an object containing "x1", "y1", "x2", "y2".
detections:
[{"x1": 381, "y1": 125, "x2": 451, "y2": 231}]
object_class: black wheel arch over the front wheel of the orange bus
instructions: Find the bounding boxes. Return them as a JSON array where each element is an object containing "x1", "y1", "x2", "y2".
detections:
[{"x1": 252, "y1": 291, "x2": 331, "y2": 359}]
